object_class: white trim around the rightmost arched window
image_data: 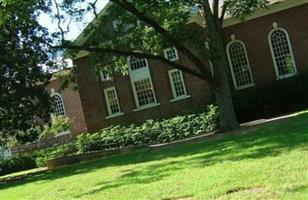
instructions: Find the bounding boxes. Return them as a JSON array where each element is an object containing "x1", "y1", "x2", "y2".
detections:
[{"x1": 268, "y1": 23, "x2": 298, "y2": 80}]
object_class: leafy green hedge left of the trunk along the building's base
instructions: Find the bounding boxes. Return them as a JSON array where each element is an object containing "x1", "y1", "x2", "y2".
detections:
[{"x1": 0, "y1": 106, "x2": 218, "y2": 175}]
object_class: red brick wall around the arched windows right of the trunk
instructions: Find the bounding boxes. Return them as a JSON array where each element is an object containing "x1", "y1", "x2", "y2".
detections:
[{"x1": 224, "y1": 4, "x2": 308, "y2": 88}]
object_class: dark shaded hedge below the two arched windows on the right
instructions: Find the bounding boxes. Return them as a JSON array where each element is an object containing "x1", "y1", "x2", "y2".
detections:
[{"x1": 233, "y1": 74, "x2": 308, "y2": 122}]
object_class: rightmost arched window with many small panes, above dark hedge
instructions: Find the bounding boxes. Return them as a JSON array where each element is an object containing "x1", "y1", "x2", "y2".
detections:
[{"x1": 268, "y1": 27, "x2": 297, "y2": 79}]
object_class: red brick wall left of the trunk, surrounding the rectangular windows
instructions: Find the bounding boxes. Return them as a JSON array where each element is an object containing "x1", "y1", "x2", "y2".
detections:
[{"x1": 75, "y1": 56, "x2": 211, "y2": 134}]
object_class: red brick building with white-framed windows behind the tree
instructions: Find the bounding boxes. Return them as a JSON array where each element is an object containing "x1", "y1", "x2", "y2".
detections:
[{"x1": 50, "y1": 0, "x2": 308, "y2": 137}]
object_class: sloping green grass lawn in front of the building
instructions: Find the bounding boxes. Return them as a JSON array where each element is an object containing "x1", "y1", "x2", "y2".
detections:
[{"x1": 0, "y1": 112, "x2": 308, "y2": 200}]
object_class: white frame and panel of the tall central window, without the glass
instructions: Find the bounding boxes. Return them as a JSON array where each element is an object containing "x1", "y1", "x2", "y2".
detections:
[{"x1": 127, "y1": 57, "x2": 160, "y2": 111}]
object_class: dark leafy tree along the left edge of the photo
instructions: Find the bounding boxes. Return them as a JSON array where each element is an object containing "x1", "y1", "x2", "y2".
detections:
[{"x1": 0, "y1": 0, "x2": 52, "y2": 142}]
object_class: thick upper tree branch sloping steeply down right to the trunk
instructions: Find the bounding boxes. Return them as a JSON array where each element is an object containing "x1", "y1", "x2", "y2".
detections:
[{"x1": 110, "y1": 0, "x2": 215, "y2": 83}]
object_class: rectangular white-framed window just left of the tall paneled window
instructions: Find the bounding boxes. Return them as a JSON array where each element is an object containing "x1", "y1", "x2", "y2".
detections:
[{"x1": 104, "y1": 87, "x2": 121, "y2": 116}]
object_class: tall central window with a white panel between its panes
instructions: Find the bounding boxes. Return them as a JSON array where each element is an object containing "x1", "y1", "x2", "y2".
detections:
[{"x1": 129, "y1": 57, "x2": 157, "y2": 109}]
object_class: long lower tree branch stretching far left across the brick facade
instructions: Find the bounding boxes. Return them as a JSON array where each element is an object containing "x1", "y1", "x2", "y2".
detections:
[{"x1": 56, "y1": 45, "x2": 207, "y2": 81}]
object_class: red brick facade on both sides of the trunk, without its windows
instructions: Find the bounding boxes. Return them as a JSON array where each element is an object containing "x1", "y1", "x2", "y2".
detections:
[{"x1": 68, "y1": 4, "x2": 308, "y2": 132}]
